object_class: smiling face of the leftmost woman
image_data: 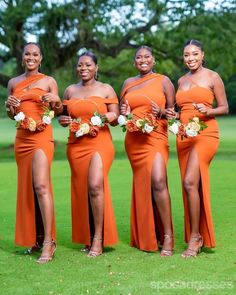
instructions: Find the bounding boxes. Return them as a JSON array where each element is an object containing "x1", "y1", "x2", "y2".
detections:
[{"x1": 22, "y1": 44, "x2": 42, "y2": 71}]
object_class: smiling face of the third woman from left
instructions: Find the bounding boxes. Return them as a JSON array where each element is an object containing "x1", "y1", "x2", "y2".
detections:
[{"x1": 134, "y1": 48, "x2": 155, "y2": 74}]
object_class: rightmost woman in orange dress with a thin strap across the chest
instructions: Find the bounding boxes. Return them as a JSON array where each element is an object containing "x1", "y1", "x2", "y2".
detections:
[{"x1": 167, "y1": 40, "x2": 228, "y2": 257}]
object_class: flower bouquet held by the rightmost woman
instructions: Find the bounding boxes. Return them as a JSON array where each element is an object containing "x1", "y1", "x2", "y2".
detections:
[{"x1": 168, "y1": 117, "x2": 207, "y2": 139}]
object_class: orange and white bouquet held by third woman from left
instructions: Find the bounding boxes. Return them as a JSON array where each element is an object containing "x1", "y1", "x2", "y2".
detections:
[{"x1": 118, "y1": 114, "x2": 158, "y2": 134}]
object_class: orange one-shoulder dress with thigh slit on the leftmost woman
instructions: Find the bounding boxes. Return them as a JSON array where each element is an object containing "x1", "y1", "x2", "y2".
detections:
[{"x1": 12, "y1": 74, "x2": 56, "y2": 247}]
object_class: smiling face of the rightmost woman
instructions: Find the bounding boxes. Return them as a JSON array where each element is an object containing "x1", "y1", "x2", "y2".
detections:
[{"x1": 184, "y1": 45, "x2": 204, "y2": 71}]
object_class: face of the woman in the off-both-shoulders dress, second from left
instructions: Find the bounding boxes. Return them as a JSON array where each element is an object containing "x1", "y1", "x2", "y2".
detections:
[{"x1": 77, "y1": 55, "x2": 98, "y2": 81}]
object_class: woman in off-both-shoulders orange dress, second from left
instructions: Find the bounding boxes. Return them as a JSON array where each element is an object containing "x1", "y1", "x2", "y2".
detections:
[{"x1": 60, "y1": 52, "x2": 118, "y2": 257}]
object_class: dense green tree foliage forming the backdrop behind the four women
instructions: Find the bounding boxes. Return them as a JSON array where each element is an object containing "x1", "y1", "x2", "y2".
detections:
[{"x1": 0, "y1": 0, "x2": 236, "y2": 114}]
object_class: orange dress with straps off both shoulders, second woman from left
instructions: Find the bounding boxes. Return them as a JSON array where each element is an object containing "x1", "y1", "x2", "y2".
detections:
[{"x1": 64, "y1": 96, "x2": 118, "y2": 246}]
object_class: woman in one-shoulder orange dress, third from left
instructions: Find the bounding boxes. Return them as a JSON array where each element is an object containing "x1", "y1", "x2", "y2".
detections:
[{"x1": 118, "y1": 46, "x2": 174, "y2": 256}]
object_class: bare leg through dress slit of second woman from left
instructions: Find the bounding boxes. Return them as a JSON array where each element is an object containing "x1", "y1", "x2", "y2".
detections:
[{"x1": 88, "y1": 153, "x2": 104, "y2": 256}]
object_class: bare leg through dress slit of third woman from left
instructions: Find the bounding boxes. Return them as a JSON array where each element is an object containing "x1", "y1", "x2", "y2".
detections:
[{"x1": 152, "y1": 153, "x2": 173, "y2": 256}]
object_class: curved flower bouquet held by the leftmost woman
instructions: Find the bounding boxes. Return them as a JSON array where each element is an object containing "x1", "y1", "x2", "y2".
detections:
[{"x1": 14, "y1": 107, "x2": 54, "y2": 131}]
